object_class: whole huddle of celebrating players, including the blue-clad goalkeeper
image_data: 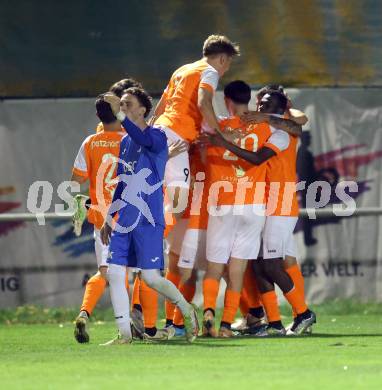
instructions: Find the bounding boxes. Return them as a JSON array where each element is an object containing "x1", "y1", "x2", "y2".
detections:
[{"x1": 72, "y1": 35, "x2": 316, "y2": 345}]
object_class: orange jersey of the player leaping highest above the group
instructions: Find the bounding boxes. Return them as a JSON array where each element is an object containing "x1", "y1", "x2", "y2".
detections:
[{"x1": 155, "y1": 59, "x2": 219, "y2": 142}]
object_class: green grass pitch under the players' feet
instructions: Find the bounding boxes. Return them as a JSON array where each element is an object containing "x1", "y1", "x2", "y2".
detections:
[{"x1": 0, "y1": 306, "x2": 382, "y2": 390}]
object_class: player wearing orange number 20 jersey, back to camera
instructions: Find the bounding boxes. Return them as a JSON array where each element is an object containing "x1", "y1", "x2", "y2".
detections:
[{"x1": 203, "y1": 80, "x2": 271, "y2": 337}]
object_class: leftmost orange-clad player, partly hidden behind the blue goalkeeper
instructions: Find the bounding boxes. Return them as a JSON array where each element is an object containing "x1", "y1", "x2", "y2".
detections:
[{"x1": 71, "y1": 95, "x2": 127, "y2": 343}]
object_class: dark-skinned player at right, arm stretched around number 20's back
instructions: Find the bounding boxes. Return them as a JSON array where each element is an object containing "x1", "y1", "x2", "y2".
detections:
[{"x1": 207, "y1": 91, "x2": 316, "y2": 335}]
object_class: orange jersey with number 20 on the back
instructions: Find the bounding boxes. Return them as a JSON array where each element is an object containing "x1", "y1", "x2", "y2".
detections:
[{"x1": 207, "y1": 117, "x2": 271, "y2": 205}]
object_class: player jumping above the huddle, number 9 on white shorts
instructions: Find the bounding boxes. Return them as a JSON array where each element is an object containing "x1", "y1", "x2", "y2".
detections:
[{"x1": 152, "y1": 35, "x2": 240, "y2": 302}]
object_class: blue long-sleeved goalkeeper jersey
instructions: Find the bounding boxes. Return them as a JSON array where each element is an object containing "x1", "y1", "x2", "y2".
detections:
[{"x1": 110, "y1": 118, "x2": 168, "y2": 232}]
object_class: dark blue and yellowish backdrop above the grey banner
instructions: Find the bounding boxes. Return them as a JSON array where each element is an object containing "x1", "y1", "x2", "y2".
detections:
[{"x1": 0, "y1": 0, "x2": 382, "y2": 97}]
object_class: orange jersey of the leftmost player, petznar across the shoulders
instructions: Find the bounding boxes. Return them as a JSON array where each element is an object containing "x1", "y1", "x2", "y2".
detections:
[{"x1": 73, "y1": 131, "x2": 126, "y2": 229}]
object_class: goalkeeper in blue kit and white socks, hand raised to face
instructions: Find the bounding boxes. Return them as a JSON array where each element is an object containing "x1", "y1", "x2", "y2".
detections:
[{"x1": 101, "y1": 88, "x2": 198, "y2": 345}]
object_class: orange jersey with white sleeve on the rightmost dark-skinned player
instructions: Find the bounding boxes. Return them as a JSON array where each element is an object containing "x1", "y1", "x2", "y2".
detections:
[{"x1": 264, "y1": 124, "x2": 299, "y2": 217}]
